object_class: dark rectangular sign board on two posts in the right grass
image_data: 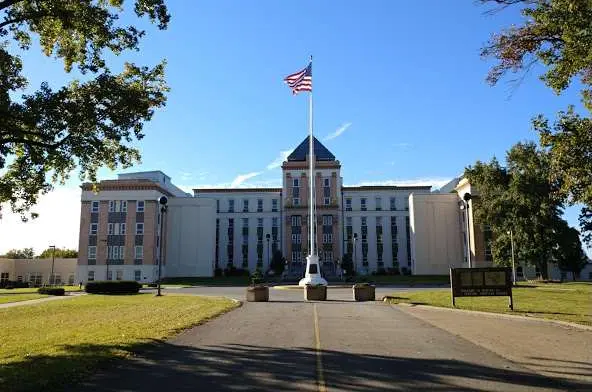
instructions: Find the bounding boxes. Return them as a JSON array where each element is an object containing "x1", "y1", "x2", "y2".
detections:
[{"x1": 450, "y1": 267, "x2": 514, "y2": 310}]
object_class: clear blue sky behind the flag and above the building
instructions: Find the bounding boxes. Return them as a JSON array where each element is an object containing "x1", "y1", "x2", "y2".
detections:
[{"x1": 0, "y1": 0, "x2": 579, "y2": 251}]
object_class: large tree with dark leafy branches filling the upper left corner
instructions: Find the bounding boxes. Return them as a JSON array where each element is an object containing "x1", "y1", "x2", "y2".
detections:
[{"x1": 0, "y1": 0, "x2": 170, "y2": 220}]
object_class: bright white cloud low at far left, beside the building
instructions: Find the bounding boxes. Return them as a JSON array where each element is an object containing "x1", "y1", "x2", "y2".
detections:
[{"x1": 0, "y1": 187, "x2": 81, "y2": 254}]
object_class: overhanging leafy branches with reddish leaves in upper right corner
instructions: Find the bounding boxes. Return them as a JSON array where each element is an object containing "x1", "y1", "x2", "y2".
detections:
[{"x1": 481, "y1": 0, "x2": 592, "y2": 111}]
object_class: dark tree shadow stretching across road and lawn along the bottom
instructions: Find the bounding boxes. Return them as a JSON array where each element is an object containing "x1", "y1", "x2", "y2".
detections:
[{"x1": 0, "y1": 341, "x2": 592, "y2": 392}]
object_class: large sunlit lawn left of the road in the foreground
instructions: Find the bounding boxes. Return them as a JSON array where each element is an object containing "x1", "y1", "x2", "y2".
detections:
[{"x1": 0, "y1": 294, "x2": 237, "y2": 391}]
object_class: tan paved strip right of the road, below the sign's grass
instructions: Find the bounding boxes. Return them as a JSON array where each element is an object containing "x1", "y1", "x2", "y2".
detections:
[{"x1": 393, "y1": 305, "x2": 592, "y2": 382}]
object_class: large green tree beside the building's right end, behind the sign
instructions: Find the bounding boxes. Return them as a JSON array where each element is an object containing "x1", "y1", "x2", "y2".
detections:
[{"x1": 465, "y1": 143, "x2": 564, "y2": 275}]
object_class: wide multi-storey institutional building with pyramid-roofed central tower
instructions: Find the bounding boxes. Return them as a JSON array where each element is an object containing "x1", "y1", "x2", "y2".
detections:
[{"x1": 78, "y1": 138, "x2": 491, "y2": 282}]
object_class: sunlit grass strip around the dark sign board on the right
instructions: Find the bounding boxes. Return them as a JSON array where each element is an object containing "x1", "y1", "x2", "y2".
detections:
[{"x1": 391, "y1": 283, "x2": 592, "y2": 325}]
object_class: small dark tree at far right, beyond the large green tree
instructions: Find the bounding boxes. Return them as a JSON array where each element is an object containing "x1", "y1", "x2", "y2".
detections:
[{"x1": 553, "y1": 224, "x2": 588, "y2": 280}]
